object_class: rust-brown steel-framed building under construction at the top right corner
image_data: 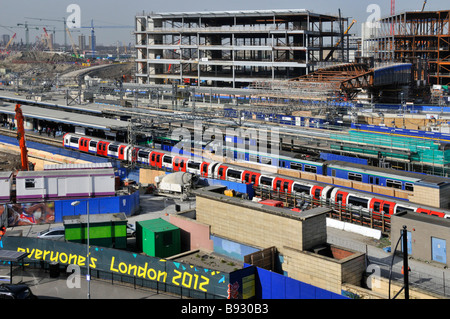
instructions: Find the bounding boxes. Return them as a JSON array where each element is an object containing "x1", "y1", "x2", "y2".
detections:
[{"x1": 362, "y1": 10, "x2": 450, "y2": 85}]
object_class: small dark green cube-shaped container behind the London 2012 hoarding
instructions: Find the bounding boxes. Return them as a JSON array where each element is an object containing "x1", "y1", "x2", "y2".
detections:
[{"x1": 136, "y1": 218, "x2": 181, "y2": 258}]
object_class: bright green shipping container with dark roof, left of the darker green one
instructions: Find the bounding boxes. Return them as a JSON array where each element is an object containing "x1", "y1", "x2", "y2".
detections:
[{"x1": 63, "y1": 213, "x2": 128, "y2": 249}]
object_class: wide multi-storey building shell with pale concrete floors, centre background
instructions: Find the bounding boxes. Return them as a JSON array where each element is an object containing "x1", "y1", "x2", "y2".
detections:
[{"x1": 135, "y1": 10, "x2": 349, "y2": 88}]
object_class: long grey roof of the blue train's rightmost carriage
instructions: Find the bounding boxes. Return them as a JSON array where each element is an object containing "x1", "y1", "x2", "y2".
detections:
[{"x1": 326, "y1": 160, "x2": 450, "y2": 187}]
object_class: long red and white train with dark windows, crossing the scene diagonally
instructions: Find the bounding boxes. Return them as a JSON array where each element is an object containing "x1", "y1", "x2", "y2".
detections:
[{"x1": 63, "y1": 133, "x2": 450, "y2": 218}]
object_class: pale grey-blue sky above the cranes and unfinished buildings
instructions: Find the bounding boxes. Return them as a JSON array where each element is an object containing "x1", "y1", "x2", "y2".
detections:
[{"x1": 0, "y1": 0, "x2": 450, "y2": 45}]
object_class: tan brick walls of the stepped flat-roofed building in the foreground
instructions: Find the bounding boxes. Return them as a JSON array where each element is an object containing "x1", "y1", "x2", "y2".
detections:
[{"x1": 196, "y1": 192, "x2": 365, "y2": 294}]
